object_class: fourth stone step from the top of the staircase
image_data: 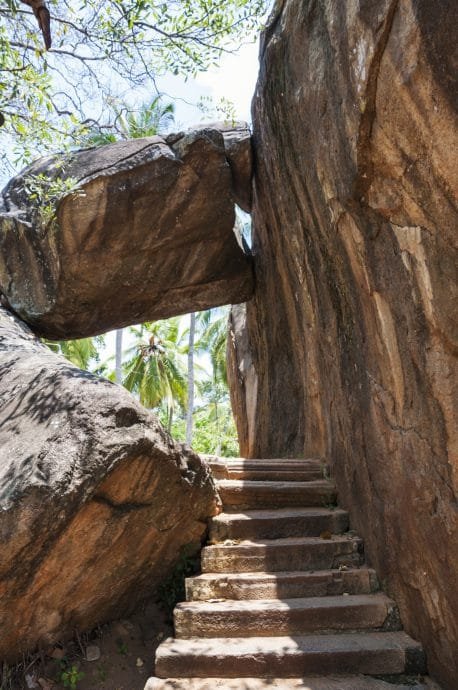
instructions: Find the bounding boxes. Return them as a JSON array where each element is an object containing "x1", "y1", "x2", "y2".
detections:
[{"x1": 202, "y1": 535, "x2": 363, "y2": 573}]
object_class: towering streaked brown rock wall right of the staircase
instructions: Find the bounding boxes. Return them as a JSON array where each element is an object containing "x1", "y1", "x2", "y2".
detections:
[{"x1": 231, "y1": 0, "x2": 458, "y2": 690}]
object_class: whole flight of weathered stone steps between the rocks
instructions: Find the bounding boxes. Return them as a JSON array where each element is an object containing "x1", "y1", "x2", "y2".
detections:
[{"x1": 145, "y1": 459, "x2": 435, "y2": 690}]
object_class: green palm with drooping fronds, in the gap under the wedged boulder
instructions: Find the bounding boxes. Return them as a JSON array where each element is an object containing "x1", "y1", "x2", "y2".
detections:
[{"x1": 124, "y1": 317, "x2": 187, "y2": 431}]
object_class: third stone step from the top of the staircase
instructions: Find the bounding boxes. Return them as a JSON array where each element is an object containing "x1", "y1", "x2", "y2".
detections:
[{"x1": 210, "y1": 507, "x2": 348, "y2": 542}]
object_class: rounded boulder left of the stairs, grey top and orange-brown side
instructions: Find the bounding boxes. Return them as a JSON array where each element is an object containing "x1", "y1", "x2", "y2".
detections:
[{"x1": 0, "y1": 309, "x2": 218, "y2": 660}]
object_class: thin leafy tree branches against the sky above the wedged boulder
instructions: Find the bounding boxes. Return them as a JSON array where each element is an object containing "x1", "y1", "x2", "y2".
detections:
[{"x1": 0, "y1": 0, "x2": 267, "y2": 177}]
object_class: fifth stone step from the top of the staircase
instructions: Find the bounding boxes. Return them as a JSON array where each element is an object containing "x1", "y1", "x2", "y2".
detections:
[{"x1": 186, "y1": 568, "x2": 379, "y2": 601}]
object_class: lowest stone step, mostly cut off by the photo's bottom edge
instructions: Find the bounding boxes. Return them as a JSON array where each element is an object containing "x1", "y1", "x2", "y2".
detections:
[{"x1": 145, "y1": 675, "x2": 440, "y2": 690}]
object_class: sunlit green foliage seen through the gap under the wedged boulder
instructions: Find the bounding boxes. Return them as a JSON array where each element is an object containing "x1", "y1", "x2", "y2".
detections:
[{"x1": 45, "y1": 308, "x2": 239, "y2": 457}]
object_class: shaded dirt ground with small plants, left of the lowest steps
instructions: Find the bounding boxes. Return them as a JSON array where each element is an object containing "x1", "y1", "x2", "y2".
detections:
[{"x1": 8, "y1": 604, "x2": 172, "y2": 690}]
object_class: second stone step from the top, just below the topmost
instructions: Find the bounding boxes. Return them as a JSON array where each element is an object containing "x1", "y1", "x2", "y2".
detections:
[{"x1": 216, "y1": 479, "x2": 336, "y2": 512}]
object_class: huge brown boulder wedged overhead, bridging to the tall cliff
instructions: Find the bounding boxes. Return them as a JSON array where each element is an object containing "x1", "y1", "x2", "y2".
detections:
[{"x1": 0, "y1": 125, "x2": 253, "y2": 339}]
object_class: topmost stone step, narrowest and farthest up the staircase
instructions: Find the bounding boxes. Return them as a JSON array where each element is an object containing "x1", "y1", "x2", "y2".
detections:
[{"x1": 206, "y1": 457, "x2": 327, "y2": 481}]
